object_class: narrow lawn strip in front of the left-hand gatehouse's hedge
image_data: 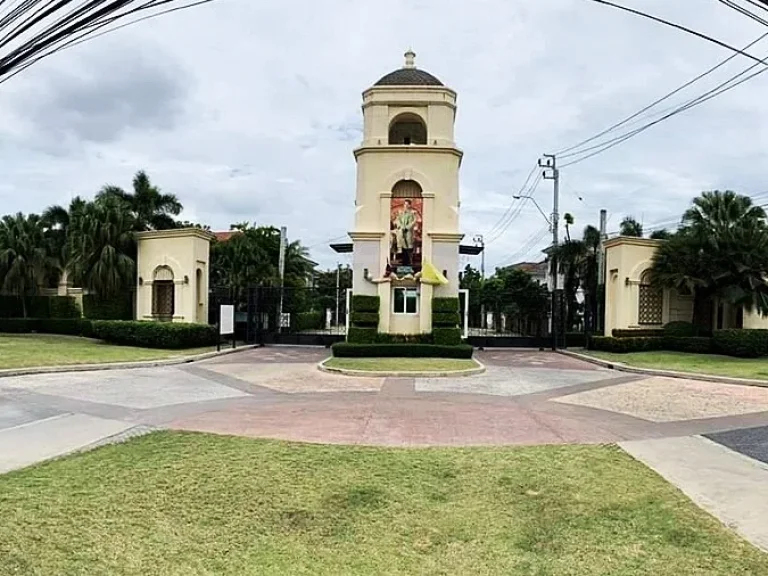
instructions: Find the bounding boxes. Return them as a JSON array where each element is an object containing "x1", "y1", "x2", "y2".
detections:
[{"x1": 0, "y1": 334, "x2": 215, "y2": 369}]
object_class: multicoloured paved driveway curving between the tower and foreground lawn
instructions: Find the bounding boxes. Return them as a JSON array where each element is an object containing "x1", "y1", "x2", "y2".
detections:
[{"x1": 0, "y1": 348, "x2": 768, "y2": 471}]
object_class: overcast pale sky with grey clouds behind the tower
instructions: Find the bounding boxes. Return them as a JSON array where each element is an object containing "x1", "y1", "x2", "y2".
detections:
[{"x1": 0, "y1": 0, "x2": 768, "y2": 271}]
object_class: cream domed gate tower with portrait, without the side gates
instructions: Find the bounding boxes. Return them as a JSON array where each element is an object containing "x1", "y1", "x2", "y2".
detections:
[{"x1": 350, "y1": 50, "x2": 462, "y2": 334}]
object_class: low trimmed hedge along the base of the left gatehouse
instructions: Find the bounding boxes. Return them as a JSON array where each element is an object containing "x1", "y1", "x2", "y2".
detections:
[{"x1": 93, "y1": 320, "x2": 219, "y2": 349}]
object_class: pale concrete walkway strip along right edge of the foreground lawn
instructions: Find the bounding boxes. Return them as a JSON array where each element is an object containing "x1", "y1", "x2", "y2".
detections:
[{"x1": 619, "y1": 436, "x2": 768, "y2": 552}]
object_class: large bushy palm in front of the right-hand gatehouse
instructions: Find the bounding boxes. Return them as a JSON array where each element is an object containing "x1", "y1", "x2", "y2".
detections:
[{"x1": 651, "y1": 191, "x2": 768, "y2": 329}]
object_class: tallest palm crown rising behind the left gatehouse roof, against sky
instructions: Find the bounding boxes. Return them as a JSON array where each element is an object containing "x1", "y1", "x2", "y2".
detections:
[{"x1": 97, "y1": 170, "x2": 184, "y2": 231}]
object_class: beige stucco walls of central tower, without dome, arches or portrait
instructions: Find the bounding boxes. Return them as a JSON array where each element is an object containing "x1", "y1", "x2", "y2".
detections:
[{"x1": 350, "y1": 64, "x2": 462, "y2": 334}]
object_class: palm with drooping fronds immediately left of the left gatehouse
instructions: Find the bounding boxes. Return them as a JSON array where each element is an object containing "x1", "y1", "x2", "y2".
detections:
[{"x1": 68, "y1": 195, "x2": 136, "y2": 298}]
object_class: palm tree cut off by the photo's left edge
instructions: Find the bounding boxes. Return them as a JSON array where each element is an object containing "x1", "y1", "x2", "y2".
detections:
[{"x1": 0, "y1": 212, "x2": 49, "y2": 318}]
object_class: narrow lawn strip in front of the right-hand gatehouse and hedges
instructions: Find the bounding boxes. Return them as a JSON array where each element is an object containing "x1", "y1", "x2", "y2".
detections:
[{"x1": 585, "y1": 350, "x2": 768, "y2": 380}]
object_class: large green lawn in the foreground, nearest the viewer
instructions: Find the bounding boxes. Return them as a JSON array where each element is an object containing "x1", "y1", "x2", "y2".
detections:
[{"x1": 0, "y1": 432, "x2": 768, "y2": 576}]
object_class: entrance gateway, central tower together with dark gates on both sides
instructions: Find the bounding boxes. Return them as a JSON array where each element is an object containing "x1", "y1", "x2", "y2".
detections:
[{"x1": 210, "y1": 50, "x2": 546, "y2": 346}]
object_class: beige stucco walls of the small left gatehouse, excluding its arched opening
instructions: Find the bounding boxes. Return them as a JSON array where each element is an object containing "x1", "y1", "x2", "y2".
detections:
[{"x1": 136, "y1": 228, "x2": 213, "y2": 324}]
